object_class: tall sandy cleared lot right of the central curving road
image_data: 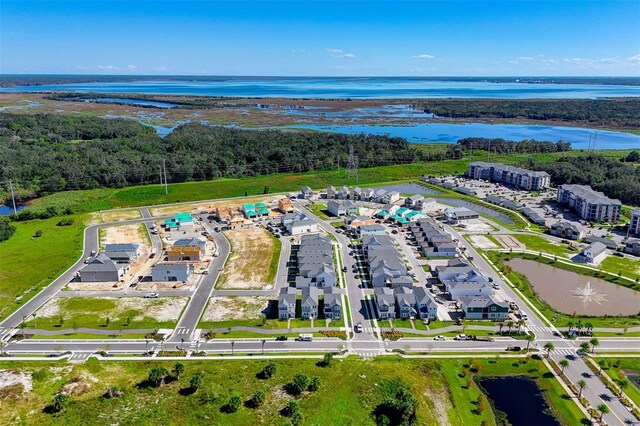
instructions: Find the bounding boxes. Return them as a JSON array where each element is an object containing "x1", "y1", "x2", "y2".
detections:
[{"x1": 216, "y1": 227, "x2": 281, "y2": 289}]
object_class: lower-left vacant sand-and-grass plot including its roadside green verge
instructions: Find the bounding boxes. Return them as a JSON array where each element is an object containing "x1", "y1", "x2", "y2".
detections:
[{"x1": 27, "y1": 297, "x2": 189, "y2": 330}]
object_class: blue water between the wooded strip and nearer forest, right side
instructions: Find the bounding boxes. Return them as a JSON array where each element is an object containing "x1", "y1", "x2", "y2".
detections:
[{"x1": 289, "y1": 122, "x2": 640, "y2": 149}]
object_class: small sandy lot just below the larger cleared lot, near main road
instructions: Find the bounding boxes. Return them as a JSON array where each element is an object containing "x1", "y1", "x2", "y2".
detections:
[{"x1": 202, "y1": 296, "x2": 270, "y2": 321}]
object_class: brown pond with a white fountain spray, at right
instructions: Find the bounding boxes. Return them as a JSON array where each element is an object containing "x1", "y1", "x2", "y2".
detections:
[{"x1": 506, "y1": 258, "x2": 640, "y2": 316}]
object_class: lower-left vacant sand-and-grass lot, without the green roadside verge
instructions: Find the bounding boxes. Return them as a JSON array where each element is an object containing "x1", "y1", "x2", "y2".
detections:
[{"x1": 37, "y1": 297, "x2": 189, "y2": 321}]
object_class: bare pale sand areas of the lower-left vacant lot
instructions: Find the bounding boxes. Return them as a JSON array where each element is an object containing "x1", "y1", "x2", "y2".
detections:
[{"x1": 37, "y1": 297, "x2": 189, "y2": 321}]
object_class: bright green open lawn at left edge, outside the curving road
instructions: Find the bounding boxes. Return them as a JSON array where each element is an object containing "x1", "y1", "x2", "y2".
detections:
[{"x1": 0, "y1": 215, "x2": 86, "y2": 319}]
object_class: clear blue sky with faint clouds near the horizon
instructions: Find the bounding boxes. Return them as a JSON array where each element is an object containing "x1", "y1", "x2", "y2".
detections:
[{"x1": 0, "y1": 0, "x2": 640, "y2": 76}]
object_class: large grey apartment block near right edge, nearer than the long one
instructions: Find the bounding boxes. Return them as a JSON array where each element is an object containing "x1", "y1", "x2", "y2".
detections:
[{"x1": 557, "y1": 185, "x2": 622, "y2": 222}]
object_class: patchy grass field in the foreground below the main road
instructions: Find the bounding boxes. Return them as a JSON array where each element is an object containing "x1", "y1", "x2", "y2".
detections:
[{"x1": 0, "y1": 358, "x2": 581, "y2": 425}]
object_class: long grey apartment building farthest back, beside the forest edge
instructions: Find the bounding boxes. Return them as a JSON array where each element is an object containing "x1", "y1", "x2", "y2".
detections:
[{"x1": 468, "y1": 161, "x2": 551, "y2": 191}]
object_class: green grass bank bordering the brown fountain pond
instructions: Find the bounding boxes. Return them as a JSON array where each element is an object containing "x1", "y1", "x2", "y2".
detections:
[{"x1": 486, "y1": 252, "x2": 640, "y2": 328}]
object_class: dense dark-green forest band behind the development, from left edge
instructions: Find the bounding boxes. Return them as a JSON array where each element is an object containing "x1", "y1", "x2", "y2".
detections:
[{"x1": 0, "y1": 113, "x2": 417, "y2": 201}]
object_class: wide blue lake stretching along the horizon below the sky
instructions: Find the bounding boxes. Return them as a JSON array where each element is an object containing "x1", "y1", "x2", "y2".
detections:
[{"x1": 0, "y1": 77, "x2": 640, "y2": 99}]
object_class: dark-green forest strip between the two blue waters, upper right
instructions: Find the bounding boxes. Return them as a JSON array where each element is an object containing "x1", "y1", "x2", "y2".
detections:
[{"x1": 414, "y1": 98, "x2": 640, "y2": 127}]
